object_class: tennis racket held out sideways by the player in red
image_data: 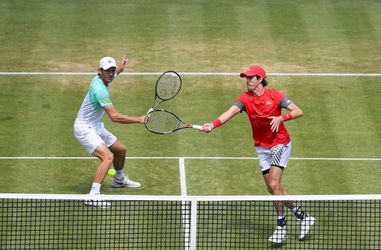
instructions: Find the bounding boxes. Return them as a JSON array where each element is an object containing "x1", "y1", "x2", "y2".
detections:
[{"x1": 144, "y1": 109, "x2": 202, "y2": 134}]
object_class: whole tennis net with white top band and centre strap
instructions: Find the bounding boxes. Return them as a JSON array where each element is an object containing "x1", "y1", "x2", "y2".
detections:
[{"x1": 0, "y1": 194, "x2": 381, "y2": 250}]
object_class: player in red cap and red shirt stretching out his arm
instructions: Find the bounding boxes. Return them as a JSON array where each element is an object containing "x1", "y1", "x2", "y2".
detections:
[{"x1": 203, "y1": 66, "x2": 315, "y2": 244}]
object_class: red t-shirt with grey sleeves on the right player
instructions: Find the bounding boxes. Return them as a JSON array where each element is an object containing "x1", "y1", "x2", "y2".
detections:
[{"x1": 235, "y1": 88, "x2": 291, "y2": 148}]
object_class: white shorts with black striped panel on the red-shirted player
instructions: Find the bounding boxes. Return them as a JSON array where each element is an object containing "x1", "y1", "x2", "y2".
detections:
[{"x1": 255, "y1": 142, "x2": 291, "y2": 174}]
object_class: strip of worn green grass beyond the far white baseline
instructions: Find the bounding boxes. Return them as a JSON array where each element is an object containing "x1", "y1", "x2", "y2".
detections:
[{"x1": 0, "y1": 0, "x2": 381, "y2": 72}]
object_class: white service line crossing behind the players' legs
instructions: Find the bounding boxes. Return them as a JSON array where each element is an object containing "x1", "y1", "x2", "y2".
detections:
[{"x1": 0, "y1": 156, "x2": 381, "y2": 161}]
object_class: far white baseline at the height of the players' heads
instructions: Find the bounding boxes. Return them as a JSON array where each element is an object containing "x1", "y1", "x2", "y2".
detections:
[{"x1": 0, "y1": 72, "x2": 381, "y2": 77}]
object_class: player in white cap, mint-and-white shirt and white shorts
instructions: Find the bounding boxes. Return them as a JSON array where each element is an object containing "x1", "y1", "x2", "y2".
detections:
[{"x1": 74, "y1": 57, "x2": 144, "y2": 206}]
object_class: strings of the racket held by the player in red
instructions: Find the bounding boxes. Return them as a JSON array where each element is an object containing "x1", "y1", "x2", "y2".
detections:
[{"x1": 145, "y1": 111, "x2": 180, "y2": 133}]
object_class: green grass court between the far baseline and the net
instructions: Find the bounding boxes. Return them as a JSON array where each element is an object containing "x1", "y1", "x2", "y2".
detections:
[{"x1": 0, "y1": 76, "x2": 381, "y2": 195}]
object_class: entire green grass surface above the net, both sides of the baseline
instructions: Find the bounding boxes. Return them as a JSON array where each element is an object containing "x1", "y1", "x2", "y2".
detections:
[{"x1": 0, "y1": 0, "x2": 381, "y2": 249}]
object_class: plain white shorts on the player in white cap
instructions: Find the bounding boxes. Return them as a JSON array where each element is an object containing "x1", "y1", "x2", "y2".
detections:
[{"x1": 74, "y1": 122, "x2": 117, "y2": 154}]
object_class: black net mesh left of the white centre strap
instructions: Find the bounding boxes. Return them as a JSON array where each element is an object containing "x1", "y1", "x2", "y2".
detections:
[{"x1": 0, "y1": 199, "x2": 190, "y2": 249}]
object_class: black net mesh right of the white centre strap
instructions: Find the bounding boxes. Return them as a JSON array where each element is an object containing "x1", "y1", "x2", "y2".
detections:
[{"x1": 197, "y1": 200, "x2": 381, "y2": 249}]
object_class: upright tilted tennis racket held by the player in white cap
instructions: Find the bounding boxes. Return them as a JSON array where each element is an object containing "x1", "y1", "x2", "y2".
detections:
[{"x1": 147, "y1": 71, "x2": 182, "y2": 114}]
